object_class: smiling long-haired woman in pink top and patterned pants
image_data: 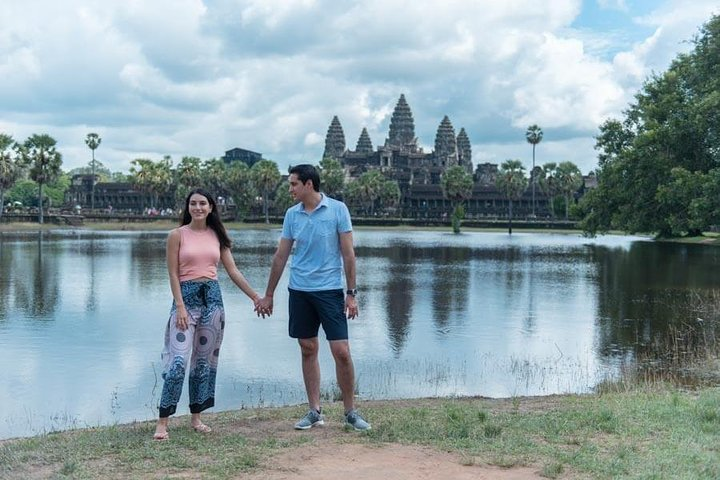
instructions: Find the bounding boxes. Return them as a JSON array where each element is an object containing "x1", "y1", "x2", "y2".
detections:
[{"x1": 153, "y1": 189, "x2": 260, "y2": 440}]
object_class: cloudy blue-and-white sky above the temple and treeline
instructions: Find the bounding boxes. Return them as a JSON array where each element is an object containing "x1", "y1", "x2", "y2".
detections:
[{"x1": 0, "y1": 0, "x2": 720, "y2": 173}]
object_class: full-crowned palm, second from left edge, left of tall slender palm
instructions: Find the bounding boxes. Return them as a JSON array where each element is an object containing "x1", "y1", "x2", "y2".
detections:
[{"x1": 19, "y1": 134, "x2": 62, "y2": 224}]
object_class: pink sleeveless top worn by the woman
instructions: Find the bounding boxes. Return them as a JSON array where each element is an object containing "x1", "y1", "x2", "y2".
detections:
[{"x1": 178, "y1": 225, "x2": 220, "y2": 282}]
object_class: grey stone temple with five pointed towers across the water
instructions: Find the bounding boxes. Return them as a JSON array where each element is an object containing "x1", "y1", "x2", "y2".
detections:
[{"x1": 323, "y1": 94, "x2": 550, "y2": 218}]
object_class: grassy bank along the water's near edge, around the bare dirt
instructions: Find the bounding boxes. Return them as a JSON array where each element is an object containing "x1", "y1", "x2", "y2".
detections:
[{"x1": 0, "y1": 385, "x2": 720, "y2": 479}]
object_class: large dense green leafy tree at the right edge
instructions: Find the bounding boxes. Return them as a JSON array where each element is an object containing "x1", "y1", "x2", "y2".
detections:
[{"x1": 578, "y1": 16, "x2": 720, "y2": 237}]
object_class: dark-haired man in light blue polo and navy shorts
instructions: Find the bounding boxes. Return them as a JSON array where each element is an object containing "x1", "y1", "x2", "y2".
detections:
[{"x1": 256, "y1": 164, "x2": 370, "y2": 430}]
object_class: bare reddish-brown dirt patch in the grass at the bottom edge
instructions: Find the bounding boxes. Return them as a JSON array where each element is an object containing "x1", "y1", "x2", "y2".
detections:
[{"x1": 242, "y1": 442, "x2": 542, "y2": 480}]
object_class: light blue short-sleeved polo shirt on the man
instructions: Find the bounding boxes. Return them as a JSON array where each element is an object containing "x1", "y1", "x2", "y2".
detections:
[{"x1": 282, "y1": 193, "x2": 352, "y2": 292}]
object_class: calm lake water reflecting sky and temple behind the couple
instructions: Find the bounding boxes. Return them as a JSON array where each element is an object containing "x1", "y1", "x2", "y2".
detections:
[{"x1": 0, "y1": 230, "x2": 720, "y2": 438}]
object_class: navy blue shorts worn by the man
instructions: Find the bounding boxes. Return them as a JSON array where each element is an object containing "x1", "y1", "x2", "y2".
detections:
[{"x1": 288, "y1": 288, "x2": 348, "y2": 340}]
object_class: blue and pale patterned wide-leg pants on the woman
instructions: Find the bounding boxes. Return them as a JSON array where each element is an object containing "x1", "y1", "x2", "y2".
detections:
[{"x1": 159, "y1": 280, "x2": 225, "y2": 418}]
